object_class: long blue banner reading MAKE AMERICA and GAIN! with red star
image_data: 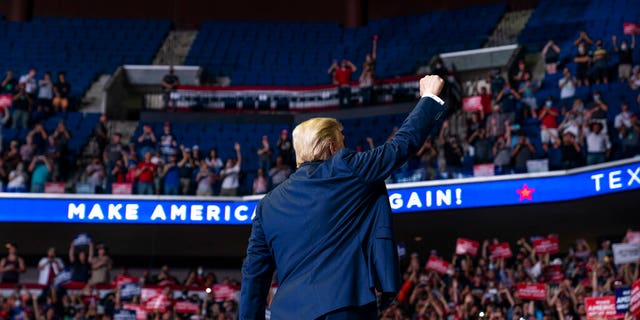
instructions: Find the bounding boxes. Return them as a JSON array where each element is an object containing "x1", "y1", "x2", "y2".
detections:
[{"x1": 0, "y1": 159, "x2": 640, "y2": 225}]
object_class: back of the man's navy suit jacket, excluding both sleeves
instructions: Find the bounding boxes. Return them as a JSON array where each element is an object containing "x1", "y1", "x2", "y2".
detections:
[{"x1": 261, "y1": 154, "x2": 390, "y2": 319}]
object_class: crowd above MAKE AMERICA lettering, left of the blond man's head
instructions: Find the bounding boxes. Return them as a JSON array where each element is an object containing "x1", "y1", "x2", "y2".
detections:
[{"x1": 84, "y1": 116, "x2": 294, "y2": 196}]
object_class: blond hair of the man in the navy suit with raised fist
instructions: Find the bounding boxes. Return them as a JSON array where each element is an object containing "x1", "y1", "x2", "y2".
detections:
[{"x1": 293, "y1": 118, "x2": 342, "y2": 167}]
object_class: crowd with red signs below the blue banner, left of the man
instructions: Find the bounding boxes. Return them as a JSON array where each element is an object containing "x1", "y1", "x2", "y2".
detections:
[{"x1": 0, "y1": 239, "x2": 239, "y2": 320}]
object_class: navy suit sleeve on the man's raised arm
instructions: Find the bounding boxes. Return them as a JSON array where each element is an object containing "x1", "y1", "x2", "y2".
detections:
[{"x1": 345, "y1": 97, "x2": 446, "y2": 182}]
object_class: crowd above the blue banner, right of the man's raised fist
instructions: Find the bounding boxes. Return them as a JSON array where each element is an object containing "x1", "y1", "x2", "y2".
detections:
[{"x1": 416, "y1": 31, "x2": 640, "y2": 180}]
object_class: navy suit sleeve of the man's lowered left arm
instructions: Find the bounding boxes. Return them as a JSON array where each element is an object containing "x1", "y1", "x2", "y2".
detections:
[{"x1": 240, "y1": 204, "x2": 275, "y2": 320}]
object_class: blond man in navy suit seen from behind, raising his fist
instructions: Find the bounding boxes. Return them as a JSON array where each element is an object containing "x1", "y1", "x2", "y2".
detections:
[{"x1": 240, "y1": 76, "x2": 445, "y2": 320}]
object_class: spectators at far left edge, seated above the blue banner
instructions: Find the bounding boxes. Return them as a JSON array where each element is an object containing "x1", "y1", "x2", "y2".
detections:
[{"x1": 0, "y1": 69, "x2": 71, "y2": 192}]
